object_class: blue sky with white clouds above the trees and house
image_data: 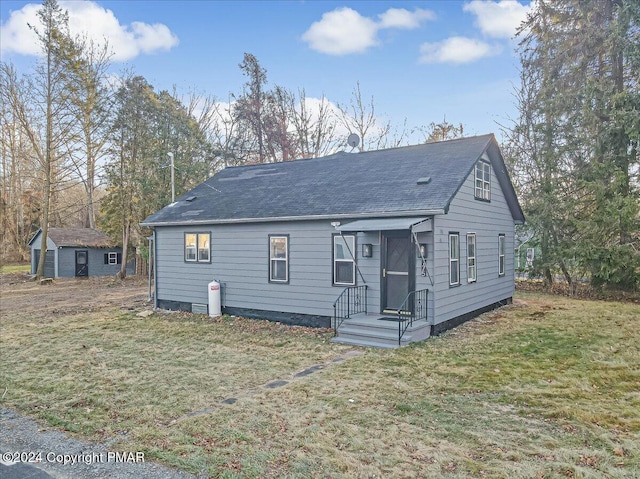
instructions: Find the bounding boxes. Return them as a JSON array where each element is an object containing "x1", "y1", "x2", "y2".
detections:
[{"x1": 0, "y1": 0, "x2": 530, "y2": 142}]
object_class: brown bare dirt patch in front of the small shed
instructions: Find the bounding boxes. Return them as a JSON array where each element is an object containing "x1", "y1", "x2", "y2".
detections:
[{"x1": 0, "y1": 273, "x2": 148, "y2": 321}]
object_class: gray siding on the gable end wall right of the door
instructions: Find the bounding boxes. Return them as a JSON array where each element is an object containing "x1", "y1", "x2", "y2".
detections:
[{"x1": 433, "y1": 158, "x2": 514, "y2": 324}]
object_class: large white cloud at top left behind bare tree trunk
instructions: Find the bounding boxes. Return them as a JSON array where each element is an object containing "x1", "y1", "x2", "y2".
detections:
[{"x1": 0, "y1": 1, "x2": 179, "y2": 61}]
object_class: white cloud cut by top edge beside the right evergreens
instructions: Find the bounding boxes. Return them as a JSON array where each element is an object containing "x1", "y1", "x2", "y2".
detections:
[{"x1": 463, "y1": 0, "x2": 533, "y2": 38}]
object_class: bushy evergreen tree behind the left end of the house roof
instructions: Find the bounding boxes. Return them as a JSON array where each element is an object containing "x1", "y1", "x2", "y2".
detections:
[{"x1": 100, "y1": 76, "x2": 213, "y2": 278}]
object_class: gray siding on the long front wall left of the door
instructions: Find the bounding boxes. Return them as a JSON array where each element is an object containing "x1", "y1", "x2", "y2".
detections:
[{"x1": 156, "y1": 221, "x2": 380, "y2": 316}]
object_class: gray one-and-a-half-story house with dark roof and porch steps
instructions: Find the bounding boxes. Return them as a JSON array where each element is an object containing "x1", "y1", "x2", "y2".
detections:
[{"x1": 142, "y1": 135, "x2": 524, "y2": 347}]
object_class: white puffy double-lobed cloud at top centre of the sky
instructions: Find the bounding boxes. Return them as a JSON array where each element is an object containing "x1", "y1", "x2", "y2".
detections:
[{"x1": 302, "y1": 7, "x2": 434, "y2": 55}]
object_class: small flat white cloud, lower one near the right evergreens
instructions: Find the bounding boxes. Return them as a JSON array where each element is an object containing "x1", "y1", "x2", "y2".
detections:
[{"x1": 420, "y1": 37, "x2": 501, "y2": 64}]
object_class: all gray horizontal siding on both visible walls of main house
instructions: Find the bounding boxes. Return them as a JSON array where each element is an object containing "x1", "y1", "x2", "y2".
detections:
[{"x1": 155, "y1": 158, "x2": 514, "y2": 324}]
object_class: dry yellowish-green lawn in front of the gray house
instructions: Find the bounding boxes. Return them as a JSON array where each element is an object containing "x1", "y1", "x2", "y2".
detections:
[{"x1": 0, "y1": 288, "x2": 640, "y2": 478}]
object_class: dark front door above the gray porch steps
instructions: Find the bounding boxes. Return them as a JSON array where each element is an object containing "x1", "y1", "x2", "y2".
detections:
[{"x1": 381, "y1": 231, "x2": 415, "y2": 312}]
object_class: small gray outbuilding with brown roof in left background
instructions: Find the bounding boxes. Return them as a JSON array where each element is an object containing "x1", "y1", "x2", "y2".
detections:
[{"x1": 29, "y1": 228, "x2": 135, "y2": 278}]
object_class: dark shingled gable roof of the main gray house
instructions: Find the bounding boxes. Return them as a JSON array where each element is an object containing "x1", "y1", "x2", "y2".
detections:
[{"x1": 142, "y1": 135, "x2": 524, "y2": 226}]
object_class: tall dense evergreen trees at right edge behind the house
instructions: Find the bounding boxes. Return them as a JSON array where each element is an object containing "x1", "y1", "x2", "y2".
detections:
[{"x1": 506, "y1": 0, "x2": 640, "y2": 288}]
